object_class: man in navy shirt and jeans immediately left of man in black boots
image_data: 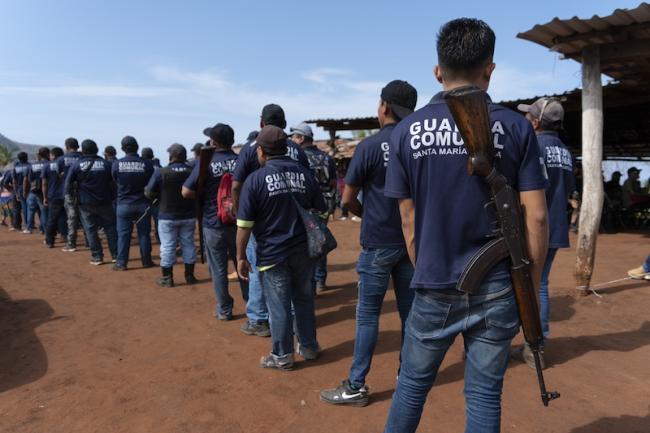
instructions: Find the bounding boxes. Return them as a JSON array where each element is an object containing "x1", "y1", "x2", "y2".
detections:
[{"x1": 111, "y1": 135, "x2": 154, "y2": 271}]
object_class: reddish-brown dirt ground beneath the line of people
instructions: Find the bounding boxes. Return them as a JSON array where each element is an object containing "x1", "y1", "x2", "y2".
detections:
[{"x1": 0, "y1": 221, "x2": 650, "y2": 433}]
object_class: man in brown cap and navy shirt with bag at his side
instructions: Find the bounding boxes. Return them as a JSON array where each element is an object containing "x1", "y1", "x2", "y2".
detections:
[{"x1": 237, "y1": 125, "x2": 327, "y2": 370}]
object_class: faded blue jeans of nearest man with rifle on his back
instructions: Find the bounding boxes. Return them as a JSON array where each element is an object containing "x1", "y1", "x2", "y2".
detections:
[{"x1": 384, "y1": 279, "x2": 519, "y2": 433}]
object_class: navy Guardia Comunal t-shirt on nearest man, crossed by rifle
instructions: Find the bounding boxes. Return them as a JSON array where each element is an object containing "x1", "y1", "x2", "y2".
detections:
[{"x1": 384, "y1": 93, "x2": 547, "y2": 289}]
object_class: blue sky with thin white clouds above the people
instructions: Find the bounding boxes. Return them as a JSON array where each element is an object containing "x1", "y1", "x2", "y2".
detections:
[{"x1": 0, "y1": 0, "x2": 639, "y2": 159}]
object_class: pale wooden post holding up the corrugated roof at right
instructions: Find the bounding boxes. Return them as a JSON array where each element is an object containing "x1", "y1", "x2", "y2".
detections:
[{"x1": 575, "y1": 45, "x2": 603, "y2": 295}]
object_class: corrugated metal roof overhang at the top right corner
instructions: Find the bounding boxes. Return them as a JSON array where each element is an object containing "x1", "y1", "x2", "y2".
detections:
[{"x1": 517, "y1": 3, "x2": 650, "y2": 85}]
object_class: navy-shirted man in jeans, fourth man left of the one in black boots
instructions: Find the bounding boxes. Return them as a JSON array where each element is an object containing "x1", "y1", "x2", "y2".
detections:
[{"x1": 41, "y1": 147, "x2": 68, "y2": 248}]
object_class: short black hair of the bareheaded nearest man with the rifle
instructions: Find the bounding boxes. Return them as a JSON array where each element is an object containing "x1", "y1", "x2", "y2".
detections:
[{"x1": 436, "y1": 18, "x2": 496, "y2": 77}]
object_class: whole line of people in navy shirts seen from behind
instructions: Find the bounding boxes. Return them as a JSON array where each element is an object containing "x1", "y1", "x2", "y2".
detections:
[{"x1": 1, "y1": 18, "x2": 612, "y2": 433}]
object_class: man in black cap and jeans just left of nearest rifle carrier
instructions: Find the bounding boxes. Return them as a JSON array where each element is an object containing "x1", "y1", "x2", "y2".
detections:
[{"x1": 321, "y1": 80, "x2": 417, "y2": 406}]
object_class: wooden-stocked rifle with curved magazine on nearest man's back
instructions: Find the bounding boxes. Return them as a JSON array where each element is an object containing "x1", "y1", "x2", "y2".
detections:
[{"x1": 445, "y1": 86, "x2": 560, "y2": 406}]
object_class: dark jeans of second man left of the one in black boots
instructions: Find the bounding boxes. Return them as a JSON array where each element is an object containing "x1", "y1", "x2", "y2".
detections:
[{"x1": 79, "y1": 203, "x2": 117, "y2": 260}]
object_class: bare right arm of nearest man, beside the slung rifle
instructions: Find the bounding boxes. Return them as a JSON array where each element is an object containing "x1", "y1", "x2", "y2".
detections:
[{"x1": 519, "y1": 189, "x2": 548, "y2": 290}]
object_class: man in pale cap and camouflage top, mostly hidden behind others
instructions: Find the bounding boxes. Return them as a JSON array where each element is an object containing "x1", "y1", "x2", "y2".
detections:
[{"x1": 290, "y1": 122, "x2": 336, "y2": 292}]
